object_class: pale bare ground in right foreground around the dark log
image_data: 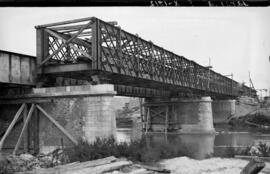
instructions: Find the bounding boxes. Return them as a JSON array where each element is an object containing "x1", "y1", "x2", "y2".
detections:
[{"x1": 161, "y1": 157, "x2": 270, "y2": 174}]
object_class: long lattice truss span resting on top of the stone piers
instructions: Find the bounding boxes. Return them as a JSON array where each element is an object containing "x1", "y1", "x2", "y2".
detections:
[{"x1": 32, "y1": 17, "x2": 256, "y2": 98}]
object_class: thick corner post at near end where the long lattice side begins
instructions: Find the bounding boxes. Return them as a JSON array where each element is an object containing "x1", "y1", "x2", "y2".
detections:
[{"x1": 92, "y1": 18, "x2": 102, "y2": 70}]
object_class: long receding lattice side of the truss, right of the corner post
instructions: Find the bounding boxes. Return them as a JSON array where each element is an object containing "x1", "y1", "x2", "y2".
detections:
[{"x1": 99, "y1": 21, "x2": 237, "y2": 94}]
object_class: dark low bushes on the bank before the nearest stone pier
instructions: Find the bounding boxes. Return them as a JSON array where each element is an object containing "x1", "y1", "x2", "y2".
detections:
[{"x1": 63, "y1": 137, "x2": 189, "y2": 162}]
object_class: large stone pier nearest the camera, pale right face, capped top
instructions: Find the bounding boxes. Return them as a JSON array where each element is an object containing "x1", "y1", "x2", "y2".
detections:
[{"x1": 34, "y1": 84, "x2": 116, "y2": 152}]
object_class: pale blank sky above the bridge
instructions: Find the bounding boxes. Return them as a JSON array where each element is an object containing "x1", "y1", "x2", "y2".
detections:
[{"x1": 0, "y1": 7, "x2": 270, "y2": 95}]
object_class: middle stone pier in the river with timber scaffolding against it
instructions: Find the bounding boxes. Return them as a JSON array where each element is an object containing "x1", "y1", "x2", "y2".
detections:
[{"x1": 143, "y1": 97, "x2": 215, "y2": 134}]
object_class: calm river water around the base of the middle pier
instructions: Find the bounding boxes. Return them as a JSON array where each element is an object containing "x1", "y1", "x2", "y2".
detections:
[{"x1": 116, "y1": 123, "x2": 270, "y2": 159}]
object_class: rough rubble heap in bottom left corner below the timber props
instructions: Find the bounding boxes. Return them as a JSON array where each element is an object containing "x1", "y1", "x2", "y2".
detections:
[{"x1": 0, "y1": 150, "x2": 64, "y2": 174}]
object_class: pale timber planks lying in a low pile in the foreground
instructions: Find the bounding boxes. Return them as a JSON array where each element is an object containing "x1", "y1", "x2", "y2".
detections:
[{"x1": 13, "y1": 156, "x2": 170, "y2": 174}]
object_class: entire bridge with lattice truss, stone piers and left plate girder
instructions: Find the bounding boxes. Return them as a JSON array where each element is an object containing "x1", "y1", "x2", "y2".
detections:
[{"x1": 0, "y1": 17, "x2": 256, "y2": 154}]
